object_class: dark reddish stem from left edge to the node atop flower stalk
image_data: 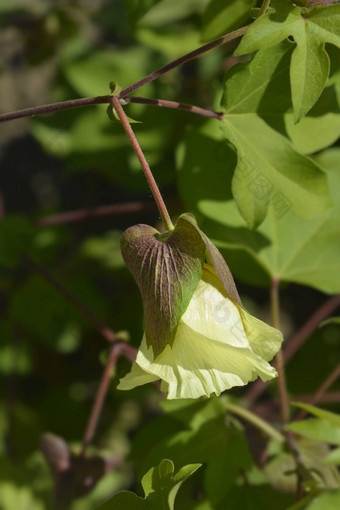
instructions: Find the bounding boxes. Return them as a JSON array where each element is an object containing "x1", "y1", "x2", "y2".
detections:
[{"x1": 0, "y1": 95, "x2": 112, "y2": 122}]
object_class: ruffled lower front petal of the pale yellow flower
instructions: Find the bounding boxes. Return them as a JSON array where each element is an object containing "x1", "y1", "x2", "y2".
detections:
[{"x1": 131, "y1": 322, "x2": 277, "y2": 399}]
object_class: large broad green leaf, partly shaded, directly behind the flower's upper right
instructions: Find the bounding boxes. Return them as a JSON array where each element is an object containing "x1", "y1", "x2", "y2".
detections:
[{"x1": 179, "y1": 115, "x2": 340, "y2": 294}]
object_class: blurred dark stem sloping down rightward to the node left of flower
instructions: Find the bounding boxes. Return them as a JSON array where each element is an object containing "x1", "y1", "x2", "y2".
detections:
[{"x1": 23, "y1": 255, "x2": 118, "y2": 343}]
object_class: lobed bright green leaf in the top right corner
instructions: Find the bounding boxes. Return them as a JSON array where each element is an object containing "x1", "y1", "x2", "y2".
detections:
[{"x1": 236, "y1": 0, "x2": 340, "y2": 122}]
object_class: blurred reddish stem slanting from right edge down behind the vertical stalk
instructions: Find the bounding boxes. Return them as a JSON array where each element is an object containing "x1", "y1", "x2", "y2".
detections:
[{"x1": 246, "y1": 295, "x2": 340, "y2": 403}]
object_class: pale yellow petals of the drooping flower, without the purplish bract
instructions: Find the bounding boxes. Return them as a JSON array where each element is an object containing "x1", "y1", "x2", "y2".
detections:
[{"x1": 118, "y1": 264, "x2": 282, "y2": 399}]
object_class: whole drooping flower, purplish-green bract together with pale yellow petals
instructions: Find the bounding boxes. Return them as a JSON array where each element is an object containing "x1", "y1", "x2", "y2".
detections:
[{"x1": 118, "y1": 215, "x2": 282, "y2": 399}]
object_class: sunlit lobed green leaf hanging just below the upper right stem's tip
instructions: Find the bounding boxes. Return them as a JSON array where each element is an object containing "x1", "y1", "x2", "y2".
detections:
[{"x1": 223, "y1": 114, "x2": 330, "y2": 228}]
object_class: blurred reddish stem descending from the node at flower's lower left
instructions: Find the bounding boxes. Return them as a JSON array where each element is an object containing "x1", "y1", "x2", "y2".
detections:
[{"x1": 80, "y1": 342, "x2": 136, "y2": 456}]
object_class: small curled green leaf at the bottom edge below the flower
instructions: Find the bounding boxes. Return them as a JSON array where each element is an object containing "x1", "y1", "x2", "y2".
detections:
[{"x1": 99, "y1": 459, "x2": 201, "y2": 510}]
